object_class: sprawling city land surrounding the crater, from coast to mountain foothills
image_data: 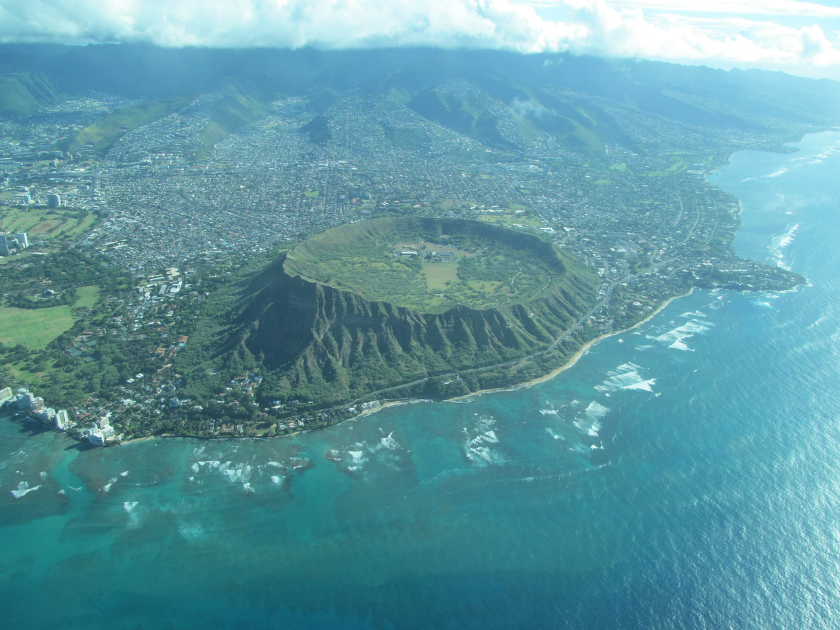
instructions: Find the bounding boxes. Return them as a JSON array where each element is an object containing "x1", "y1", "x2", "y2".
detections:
[{"x1": 0, "y1": 75, "x2": 811, "y2": 445}]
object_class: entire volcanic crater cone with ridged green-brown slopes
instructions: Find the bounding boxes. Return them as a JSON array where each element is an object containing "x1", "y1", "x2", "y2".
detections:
[{"x1": 175, "y1": 217, "x2": 598, "y2": 408}]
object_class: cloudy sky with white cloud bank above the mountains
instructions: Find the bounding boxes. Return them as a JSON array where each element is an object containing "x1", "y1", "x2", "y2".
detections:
[{"x1": 0, "y1": 0, "x2": 840, "y2": 80}]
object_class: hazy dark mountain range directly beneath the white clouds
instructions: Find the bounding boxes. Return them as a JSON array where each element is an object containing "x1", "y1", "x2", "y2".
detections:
[{"x1": 0, "y1": 45, "x2": 840, "y2": 144}]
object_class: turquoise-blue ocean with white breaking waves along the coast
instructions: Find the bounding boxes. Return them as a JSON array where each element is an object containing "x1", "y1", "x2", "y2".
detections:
[{"x1": 0, "y1": 132, "x2": 840, "y2": 630}]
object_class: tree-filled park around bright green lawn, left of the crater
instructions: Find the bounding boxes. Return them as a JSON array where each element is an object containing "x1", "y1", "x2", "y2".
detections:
[{"x1": 0, "y1": 251, "x2": 133, "y2": 406}]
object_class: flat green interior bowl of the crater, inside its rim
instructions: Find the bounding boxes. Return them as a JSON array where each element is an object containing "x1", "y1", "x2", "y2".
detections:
[{"x1": 285, "y1": 217, "x2": 566, "y2": 313}]
